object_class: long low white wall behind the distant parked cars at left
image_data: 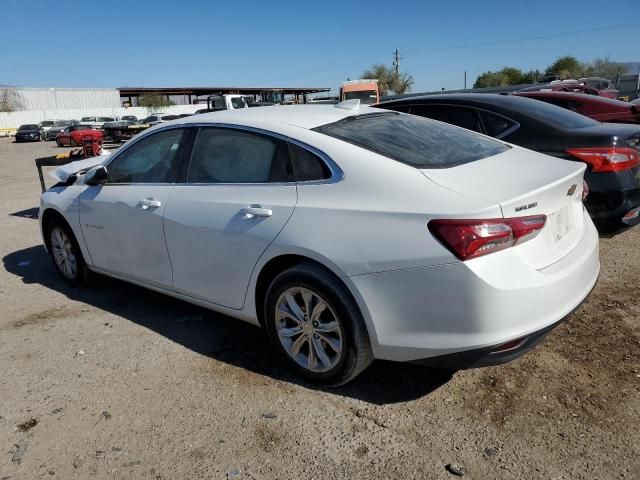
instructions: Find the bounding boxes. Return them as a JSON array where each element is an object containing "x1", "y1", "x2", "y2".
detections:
[{"x1": 0, "y1": 105, "x2": 206, "y2": 129}]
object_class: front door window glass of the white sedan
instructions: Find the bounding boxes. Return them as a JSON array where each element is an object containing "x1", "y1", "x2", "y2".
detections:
[{"x1": 107, "y1": 128, "x2": 185, "y2": 183}]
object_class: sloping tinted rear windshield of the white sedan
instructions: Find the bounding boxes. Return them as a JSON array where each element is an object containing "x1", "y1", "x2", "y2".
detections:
[{"x1": 313, "y1": 112, "x2": 510, "y2": 168}]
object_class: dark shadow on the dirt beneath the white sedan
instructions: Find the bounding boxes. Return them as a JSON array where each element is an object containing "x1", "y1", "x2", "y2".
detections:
[{"x1": 2, "y1": 245, "x2": 454, "y2": 405}]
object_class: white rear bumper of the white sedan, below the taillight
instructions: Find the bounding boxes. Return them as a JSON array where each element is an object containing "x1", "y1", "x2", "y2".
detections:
[{"x1": 349, "y1": 208, "x2": 600, "y2": 362}]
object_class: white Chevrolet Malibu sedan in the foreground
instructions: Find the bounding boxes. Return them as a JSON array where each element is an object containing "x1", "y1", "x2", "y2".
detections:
[{"x1": 40, "y1": 101, "x2": 600, "y2": 385}]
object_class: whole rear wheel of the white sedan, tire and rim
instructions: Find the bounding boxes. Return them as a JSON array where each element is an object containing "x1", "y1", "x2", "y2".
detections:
[{"x1": 264, "y1": 263, "x2": 373, "y2": 386}]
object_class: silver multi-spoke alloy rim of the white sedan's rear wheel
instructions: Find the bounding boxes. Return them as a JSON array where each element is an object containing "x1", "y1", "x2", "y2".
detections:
[{"x1": 275, "y1": 287, "x2": 344, "y2": 373}]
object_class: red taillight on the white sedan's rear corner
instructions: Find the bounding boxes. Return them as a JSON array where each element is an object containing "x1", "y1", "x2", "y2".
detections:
[{"x1": 427, "y1": 215, "x2": 547, "y2": 261}]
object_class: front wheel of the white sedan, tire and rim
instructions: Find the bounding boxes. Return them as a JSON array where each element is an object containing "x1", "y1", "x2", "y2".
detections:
[{"x1": 46, "y1": 219, "x2": 90, "y2": 285}]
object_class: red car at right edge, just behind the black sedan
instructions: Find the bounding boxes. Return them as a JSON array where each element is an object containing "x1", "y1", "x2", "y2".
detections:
[{"x1": 513, "y1": 92, "x2": 640, "y2": 123}]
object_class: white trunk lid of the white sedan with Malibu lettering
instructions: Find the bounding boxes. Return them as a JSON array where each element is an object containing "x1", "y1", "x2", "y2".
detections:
[{"x1": 421, "y1": 146, "x2": 586, "y2": 269}]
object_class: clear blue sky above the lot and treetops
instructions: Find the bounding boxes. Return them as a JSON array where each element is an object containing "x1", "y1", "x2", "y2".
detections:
[{"x1": 0, "y1": 0, "x2": 640, "y2": 91}]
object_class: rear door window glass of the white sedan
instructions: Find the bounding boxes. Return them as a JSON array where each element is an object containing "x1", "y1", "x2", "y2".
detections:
[{"x1": 187, "y1": 128, "x2": 291, "y2": 183}]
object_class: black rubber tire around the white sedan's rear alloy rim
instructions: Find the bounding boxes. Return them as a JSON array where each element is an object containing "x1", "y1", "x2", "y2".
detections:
[{"x1": 263, "y1": 263, "x2": 373, "y2": 386}]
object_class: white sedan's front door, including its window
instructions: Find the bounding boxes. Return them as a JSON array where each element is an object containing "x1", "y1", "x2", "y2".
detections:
[{"x1": 80, "y1": 128, "x2": 187, "y2": 288}]
